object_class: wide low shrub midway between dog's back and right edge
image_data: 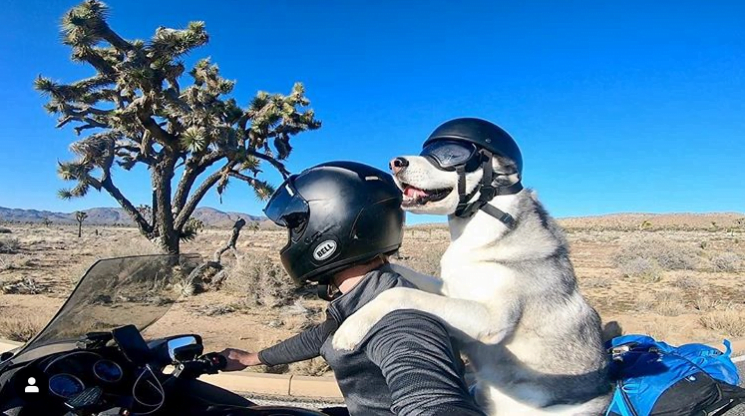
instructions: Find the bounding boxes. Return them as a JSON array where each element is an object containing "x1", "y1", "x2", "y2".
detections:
[{"x1": 614, "y1": 236, "x2": 699, "y2": 270}]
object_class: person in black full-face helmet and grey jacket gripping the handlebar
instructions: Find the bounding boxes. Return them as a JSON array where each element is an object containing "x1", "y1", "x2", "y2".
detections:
[{"x1": 221, "y1": 162, "x2": 484, "y2": 416}]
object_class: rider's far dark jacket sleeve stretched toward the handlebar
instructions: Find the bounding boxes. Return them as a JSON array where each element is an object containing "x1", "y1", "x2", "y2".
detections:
[{"x1": 259, "y1": 318, "x2": 337, "y2": 366}]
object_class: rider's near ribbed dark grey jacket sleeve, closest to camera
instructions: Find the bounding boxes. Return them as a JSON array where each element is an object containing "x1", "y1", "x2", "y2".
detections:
[{"x1": 364, "y1": 310, "x2": 485, "y2": 416}]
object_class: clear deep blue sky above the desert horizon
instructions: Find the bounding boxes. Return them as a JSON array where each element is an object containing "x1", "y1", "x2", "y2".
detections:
[{"x1": 0, "y1": 0, "x2": 745, "y2": 222}]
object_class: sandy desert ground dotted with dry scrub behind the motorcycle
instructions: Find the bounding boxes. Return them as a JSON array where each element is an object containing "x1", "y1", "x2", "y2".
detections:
[{"x1": 0, "y1": 214, "x2": 745, "y2": 375}]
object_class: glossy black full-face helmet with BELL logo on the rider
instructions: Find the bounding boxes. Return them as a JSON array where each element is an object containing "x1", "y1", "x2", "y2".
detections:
[{"x1": 264, "y1": 162, "x2": 404, "y2": 285}]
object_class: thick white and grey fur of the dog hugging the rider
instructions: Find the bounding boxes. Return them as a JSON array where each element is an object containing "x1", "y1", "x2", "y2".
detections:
[{"x1": 333, "y1": 156, "x2": 610, "y2": 416}]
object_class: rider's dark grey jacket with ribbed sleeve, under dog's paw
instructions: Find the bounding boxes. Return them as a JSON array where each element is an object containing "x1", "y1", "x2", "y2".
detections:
[{"x1": 259, "y1": 266, "x2": 484, "y2": 416}]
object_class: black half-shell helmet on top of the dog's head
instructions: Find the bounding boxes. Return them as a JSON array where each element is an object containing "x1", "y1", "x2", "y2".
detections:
[{"x1": 423, "y1": 118, "x2": 523, "y2": 176}]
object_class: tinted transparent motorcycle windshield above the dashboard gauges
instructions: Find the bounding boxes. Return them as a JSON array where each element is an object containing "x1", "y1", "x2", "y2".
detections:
[{"x1": 13, "y1": 255, "x2": 199, "y2": 361}]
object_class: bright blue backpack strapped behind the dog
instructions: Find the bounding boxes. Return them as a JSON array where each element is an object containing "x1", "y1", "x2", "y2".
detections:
[{"x1": 605, "y1": 335, "x2": 745, "y2": 416}]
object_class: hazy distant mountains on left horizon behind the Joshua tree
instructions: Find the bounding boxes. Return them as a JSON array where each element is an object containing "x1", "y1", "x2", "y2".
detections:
[{"x1": 0, "y1": 207, "x2": 266, "y2": 228}]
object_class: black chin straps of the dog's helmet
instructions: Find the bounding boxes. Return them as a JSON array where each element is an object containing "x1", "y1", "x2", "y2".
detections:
[{"x1": 455, "y1": 149, "x2": 523, "y2": 229}]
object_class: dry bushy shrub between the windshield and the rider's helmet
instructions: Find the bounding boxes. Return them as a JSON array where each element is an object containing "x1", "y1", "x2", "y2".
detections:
[{"x1": 225, "y1": 253, "x2": 299, "y2": 307}]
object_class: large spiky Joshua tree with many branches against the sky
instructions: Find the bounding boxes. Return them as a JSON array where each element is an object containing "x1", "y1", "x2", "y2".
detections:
[{"x1": 35, "y1": 0, "x2": 321, "y2": 253}]
